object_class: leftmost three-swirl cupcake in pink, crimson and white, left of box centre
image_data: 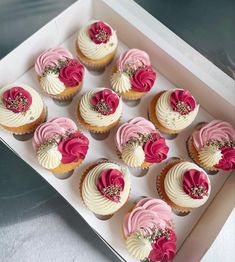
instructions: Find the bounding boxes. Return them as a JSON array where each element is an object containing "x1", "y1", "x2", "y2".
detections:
[{"x1": 33, "y1": 117, "x2": 89, "y2": 178}]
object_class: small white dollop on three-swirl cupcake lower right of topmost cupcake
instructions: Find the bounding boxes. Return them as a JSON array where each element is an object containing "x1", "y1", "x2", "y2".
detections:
[{"x1": 110, "y1": 72, "x2": 131, "y2": 93}]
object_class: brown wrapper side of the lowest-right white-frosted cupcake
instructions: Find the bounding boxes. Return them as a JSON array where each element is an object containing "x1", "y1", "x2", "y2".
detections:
[{"x1": 156, "y1": 160, "x2": 192, "y2": 214}]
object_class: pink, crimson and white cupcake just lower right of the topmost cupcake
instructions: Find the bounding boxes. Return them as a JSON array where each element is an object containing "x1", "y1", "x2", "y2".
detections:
[{"x1": 110, "y1": 49, "x2": 156, "y2": 100}]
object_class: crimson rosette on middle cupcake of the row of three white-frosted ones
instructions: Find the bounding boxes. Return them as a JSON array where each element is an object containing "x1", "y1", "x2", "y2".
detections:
[{"x1": 91, "y1": 88, "x2": 119, "y2": 115}]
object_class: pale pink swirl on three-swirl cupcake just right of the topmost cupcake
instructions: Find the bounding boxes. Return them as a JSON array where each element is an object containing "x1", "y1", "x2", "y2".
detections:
[{"x1": 117, "y1": 49, "x2": 150, "y2": 72}]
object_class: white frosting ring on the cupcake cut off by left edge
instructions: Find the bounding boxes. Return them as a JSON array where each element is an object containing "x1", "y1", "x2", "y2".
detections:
[{"x1": 0, "y1": 83, "x2": 44, "y2": 127}]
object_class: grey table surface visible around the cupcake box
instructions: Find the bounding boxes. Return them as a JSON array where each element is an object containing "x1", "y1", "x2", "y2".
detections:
[{"x1": 0, "y1": 0, "x2": 235, "y2": 262}]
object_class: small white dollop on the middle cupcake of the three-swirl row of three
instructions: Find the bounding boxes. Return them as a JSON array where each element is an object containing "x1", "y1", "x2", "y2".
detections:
[{"x1": 122, "y1": 144, "x2": 145, "y2": 167}]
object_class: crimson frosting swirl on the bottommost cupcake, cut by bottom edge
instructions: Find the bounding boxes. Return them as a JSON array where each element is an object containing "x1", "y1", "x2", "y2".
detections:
[{"x1": 148, "y1": 231, "x2": 176, "y2": 262}]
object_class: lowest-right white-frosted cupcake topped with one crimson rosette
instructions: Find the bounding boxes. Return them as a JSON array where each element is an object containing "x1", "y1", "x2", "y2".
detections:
[{"x1": 157, "y1": 160, "x2": 211, "y2": 212}]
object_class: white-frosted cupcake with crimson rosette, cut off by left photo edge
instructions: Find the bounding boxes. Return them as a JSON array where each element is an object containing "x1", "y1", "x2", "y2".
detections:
[{"x1": 0, "y1": 83, "x2": 47, "y2": 140}]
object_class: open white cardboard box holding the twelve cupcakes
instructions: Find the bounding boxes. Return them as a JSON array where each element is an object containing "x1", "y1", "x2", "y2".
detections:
[{"x1": 0, "y1": 0, "x2": 235, "y2": 261}]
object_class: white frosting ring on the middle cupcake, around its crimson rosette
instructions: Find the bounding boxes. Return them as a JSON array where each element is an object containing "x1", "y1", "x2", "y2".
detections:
[{"x1": 80, "y1": 88, "x2": 122, "y2": 126}]
